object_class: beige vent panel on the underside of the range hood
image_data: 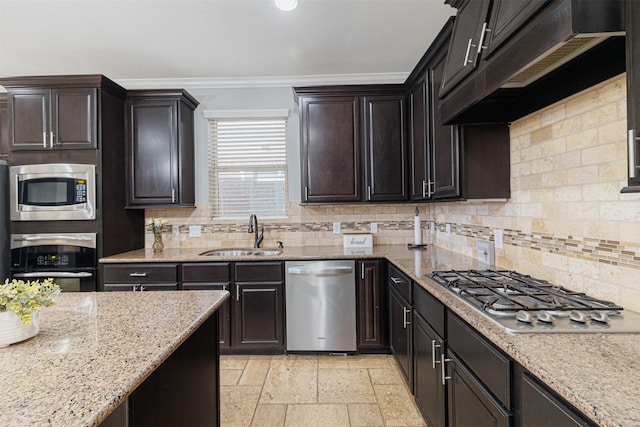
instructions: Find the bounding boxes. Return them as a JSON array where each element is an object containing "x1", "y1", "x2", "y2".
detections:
[{"x1": 500, "y1": 33, "x2": 612, "y2": 89}]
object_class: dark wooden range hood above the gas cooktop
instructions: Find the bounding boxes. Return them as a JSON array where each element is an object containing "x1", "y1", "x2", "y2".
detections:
[{"x1": 440, "y1": 0, "x2": 625, "y2": 124}]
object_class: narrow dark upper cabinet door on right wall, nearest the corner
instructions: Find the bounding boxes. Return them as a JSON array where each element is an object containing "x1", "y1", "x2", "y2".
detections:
[{"x1": 408, "y1": 74, "x2": 431, "y2": 201}]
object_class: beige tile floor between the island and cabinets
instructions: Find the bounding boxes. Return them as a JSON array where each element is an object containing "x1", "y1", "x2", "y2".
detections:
[{"x1": 220, "y1": 355, "x2": 425, "y2": 427}]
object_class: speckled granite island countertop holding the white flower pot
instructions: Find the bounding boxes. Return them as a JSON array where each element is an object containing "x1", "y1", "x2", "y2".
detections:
[{"x1": 0, "y1": 291, "x2": 229, "y2": 427}]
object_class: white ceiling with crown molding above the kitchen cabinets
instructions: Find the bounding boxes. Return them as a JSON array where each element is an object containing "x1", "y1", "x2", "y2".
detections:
[{"x1": 0, "y1": 0, "x2": 455, "y2": 88}]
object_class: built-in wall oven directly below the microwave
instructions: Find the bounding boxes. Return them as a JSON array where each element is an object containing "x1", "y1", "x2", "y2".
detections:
[{"x1": 11, "y1": 233, "x2": 97, "y2": 292}]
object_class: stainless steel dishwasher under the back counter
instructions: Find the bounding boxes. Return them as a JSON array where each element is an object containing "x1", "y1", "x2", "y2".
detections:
[{"x1": 285, "y1": 261, "x2": 356, "y2": 352}]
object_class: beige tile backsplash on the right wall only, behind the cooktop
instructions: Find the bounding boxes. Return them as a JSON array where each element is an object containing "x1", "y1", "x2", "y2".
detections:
[{"x1": 431, "y1": 75, "x2": 640, "y2": 311}]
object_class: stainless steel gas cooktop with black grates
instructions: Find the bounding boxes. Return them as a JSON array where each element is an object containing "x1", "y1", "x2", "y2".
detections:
[{"x1": 431, "y1": 270, "x2": 640, "y2": 333}]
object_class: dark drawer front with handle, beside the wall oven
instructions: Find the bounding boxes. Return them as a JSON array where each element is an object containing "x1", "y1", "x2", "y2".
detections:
[{"x1": 104, "y1": 263, "x2": 178, "y2": 283}]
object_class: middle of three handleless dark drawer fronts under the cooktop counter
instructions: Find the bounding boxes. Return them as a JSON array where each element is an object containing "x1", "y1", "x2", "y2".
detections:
[{"x1": 447, "y1": 312, "x2": 512, "y2": 409}]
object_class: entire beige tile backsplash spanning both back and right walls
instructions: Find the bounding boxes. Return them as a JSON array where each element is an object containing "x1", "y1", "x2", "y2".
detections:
[{"x1": 147, "y1": 75, "x2": 640, "y2": 311}]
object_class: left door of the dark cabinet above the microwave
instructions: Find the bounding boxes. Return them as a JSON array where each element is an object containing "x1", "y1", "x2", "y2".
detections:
[{"x1": 9, "y1": 89, "x2": 51, "y2": 150}]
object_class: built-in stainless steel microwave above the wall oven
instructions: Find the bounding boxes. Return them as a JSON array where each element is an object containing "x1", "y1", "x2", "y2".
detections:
[{"x1": 9, "y1": 163, "x2": 96, "y2": 221}]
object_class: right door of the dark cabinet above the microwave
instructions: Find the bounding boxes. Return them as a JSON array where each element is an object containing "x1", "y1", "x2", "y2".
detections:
[{"x1": 49, "y1": 88, "x2": 98, "y2": 149}]
